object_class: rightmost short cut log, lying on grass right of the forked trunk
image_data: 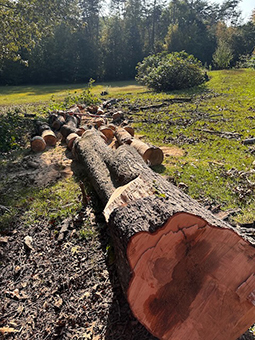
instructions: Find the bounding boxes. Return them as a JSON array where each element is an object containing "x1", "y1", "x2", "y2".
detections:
[{"x1": 131, "y1": 139, "x2": 164, "y2": 166}]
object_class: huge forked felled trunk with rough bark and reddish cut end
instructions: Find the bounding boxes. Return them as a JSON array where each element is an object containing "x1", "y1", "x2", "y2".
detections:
[{"x1": 73, "y1": 130, "x2": 255, "y2": 340}]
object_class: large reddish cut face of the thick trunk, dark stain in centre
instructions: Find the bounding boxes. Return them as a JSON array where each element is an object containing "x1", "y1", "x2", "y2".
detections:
[{"x1": 127, "y1": 213, "x2": 255, "y2": 340}]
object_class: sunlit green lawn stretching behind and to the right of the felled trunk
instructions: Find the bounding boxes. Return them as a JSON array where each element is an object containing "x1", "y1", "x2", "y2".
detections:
[{"x1": 0, "y1": 70, "x2": 255, "y2": 228}]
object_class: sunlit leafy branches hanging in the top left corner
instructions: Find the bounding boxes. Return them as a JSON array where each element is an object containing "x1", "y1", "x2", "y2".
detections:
[{"x1": 0, "y1": 0, "x2": 76, "y2": 62}]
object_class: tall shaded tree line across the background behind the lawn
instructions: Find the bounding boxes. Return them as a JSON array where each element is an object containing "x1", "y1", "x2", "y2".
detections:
[{"x1": 0, "y1": 0, "x2": 255, "y2": 85}]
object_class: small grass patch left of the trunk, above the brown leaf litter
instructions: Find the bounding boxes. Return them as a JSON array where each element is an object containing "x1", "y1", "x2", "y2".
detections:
[{"x1": 0, "y1": 178, "x2": 82, "y2": 229}]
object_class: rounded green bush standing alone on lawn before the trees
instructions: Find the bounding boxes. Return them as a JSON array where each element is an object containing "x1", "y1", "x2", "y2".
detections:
[{"x1": 136, "y1": 51, "x2": 205, "y2": 91}]
